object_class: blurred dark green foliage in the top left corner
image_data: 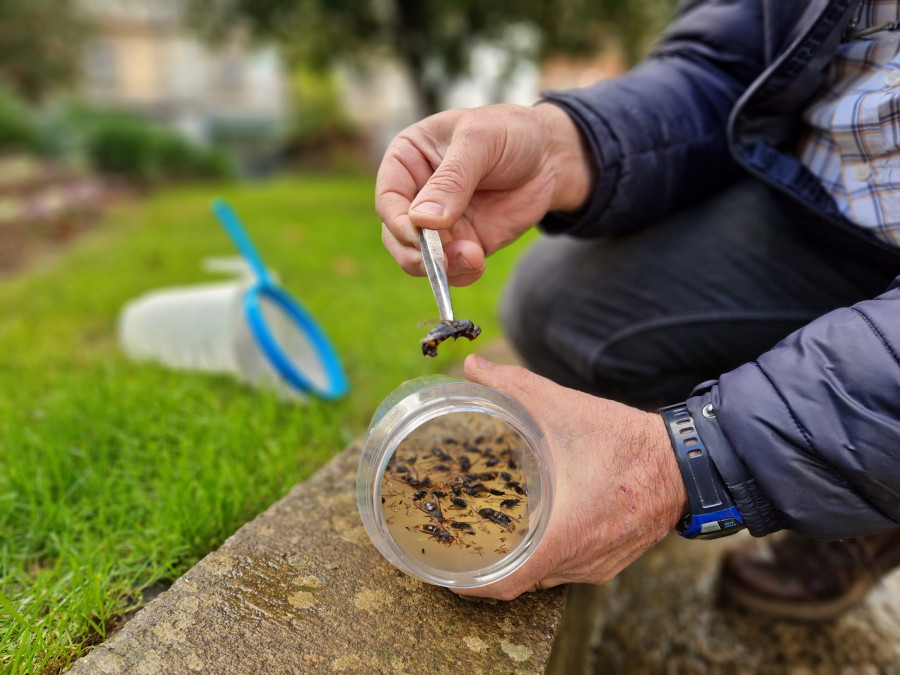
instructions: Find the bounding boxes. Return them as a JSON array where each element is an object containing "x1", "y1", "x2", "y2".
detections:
[{"x1": 0, "y1": 0, "x2": 88, "y2": 101}]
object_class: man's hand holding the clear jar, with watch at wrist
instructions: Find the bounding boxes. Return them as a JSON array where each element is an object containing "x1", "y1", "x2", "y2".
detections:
[{"x1": 457, "y1": 355, "x2": 687, "y2": 600}]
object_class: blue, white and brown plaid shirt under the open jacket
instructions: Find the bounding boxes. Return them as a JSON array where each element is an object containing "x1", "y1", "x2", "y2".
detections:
[{"x1": 799, "y1": 0, "x2": 900, "y2": 246}]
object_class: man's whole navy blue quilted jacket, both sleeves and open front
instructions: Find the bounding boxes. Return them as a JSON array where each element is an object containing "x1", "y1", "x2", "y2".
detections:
[{"x1": 542, "y1": 0, "x2": 900, "y2": 539}]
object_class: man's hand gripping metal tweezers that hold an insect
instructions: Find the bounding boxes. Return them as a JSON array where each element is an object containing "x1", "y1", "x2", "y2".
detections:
[{"x1": 375, "y1": 104, "x2": 593, "y2": 286}]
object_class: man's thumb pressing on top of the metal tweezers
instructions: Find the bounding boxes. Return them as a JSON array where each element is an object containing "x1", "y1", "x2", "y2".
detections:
[{"x1": 409, "y1": 143, "x2": 483, "y2": 230}]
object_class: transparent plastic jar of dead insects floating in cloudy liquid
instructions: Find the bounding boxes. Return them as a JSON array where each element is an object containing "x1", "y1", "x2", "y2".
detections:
[{"x1": 356, "y1": 375, "x2": 554, "y2": 588}]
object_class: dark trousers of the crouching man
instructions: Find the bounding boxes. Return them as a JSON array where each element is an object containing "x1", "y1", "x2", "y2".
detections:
[{"x1": 501, "y1": 178, "x2": 900, "y2": 409}]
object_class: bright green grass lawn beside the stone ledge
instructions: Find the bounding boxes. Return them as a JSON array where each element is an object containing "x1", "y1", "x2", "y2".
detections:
[{"x1": 0, "y1": 177, "x2": 536, "y2": 672}]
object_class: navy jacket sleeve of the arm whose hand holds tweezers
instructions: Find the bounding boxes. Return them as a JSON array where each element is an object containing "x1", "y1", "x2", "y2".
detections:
[{"x1": 541, "y1": 0, "x2": 765, "y2": 236}]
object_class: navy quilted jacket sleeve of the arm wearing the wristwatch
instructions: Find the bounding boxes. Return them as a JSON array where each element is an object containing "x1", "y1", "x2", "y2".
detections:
[{"x1": 688, "y1": 277, "x2": 900, "y2": 539}]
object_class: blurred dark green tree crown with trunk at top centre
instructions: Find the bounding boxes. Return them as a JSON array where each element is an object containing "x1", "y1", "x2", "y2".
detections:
[{"x1": 189, "y1": 0, "x2": 675, "y2": 114}]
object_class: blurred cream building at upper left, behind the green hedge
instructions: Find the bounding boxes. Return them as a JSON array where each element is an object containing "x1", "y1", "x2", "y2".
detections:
[{"x1": 80, "y1": 0, "x2": 287, "y2": 168}]
